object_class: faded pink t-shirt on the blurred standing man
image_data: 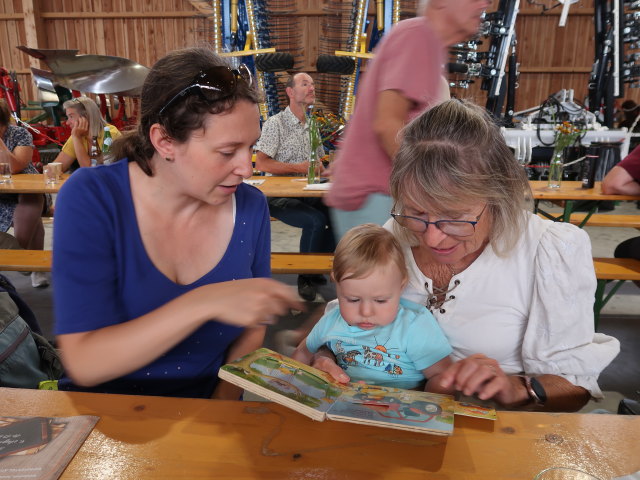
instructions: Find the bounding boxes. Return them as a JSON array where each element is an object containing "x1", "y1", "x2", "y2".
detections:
[{"x1": 325, "y1": 17, "x2": 446, "y2": 210}]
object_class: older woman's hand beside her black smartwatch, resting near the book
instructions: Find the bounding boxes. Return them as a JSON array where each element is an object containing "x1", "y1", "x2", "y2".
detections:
[{"x1": 439, "y1": 353, "x2": 529, "y2": 407}]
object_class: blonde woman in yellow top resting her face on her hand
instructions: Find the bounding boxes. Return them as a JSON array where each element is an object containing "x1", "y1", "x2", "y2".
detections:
[{"x1": 56, "y1": 97, "x2": 120, "y2": 172}]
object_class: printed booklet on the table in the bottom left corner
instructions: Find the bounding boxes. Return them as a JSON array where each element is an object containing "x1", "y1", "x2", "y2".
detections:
[{"x1": 0, "y1": 415, "x2": 99, "y2": 480}]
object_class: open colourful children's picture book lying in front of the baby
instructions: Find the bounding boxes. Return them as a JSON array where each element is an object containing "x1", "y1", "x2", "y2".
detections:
[{"x1": 218, "y1": 348, "x2": 496, "y2": 435}]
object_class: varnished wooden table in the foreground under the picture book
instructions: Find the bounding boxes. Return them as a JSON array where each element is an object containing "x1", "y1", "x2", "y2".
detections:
[{"x1": 0, "y1": 389, "x2": 640, "y2": 480}]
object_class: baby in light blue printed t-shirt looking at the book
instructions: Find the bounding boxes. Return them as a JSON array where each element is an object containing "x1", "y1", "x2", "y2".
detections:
[{"x1": 293, "y1": 223, "x2": 453, "y2": 393}]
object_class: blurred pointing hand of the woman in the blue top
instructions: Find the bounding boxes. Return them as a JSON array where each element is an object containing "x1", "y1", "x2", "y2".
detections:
[{"x1": 198, "y1": 278, "x2": 304, "y2": 327}]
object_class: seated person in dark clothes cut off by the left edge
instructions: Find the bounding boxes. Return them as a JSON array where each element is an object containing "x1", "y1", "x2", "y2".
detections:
[{"x1": 0, "y1": 99, "x2": 49, "y2": 288}]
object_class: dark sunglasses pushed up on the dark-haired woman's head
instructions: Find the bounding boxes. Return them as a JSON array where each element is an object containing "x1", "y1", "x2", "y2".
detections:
[{"x1": 158, "y1": 63, "x2": 253, "y2": 115}]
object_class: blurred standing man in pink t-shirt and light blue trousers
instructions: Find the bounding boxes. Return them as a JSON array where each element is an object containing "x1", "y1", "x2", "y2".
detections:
[{"x1": 325, "y1": 0, "x2": 490, "y2": 238}]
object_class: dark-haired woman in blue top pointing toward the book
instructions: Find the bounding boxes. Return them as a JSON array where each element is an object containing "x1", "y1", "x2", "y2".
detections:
[{"x1": 53, "y1": 49, "x2": 299, "y2": 399}]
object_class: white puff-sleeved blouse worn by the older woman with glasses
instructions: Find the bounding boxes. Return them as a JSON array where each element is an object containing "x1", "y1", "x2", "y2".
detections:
[{"x1": 385, "y1": 213, "x2": 620, "y2": 398}]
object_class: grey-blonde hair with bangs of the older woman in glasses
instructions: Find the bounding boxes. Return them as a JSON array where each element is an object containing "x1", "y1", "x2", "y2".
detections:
[{"x1": 390, "y1": 100, "x2": 532, "y2": 255}]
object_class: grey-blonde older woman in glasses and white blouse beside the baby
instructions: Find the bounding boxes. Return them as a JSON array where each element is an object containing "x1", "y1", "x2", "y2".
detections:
[{"x1": 316, "y1": 100, "x2": 619, "y2": 411}]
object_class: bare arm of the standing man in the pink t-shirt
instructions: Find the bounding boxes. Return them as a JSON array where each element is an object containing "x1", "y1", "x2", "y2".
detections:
[{"x1": 373, "y1": 90, "x2": 413, "y2": 159}]
